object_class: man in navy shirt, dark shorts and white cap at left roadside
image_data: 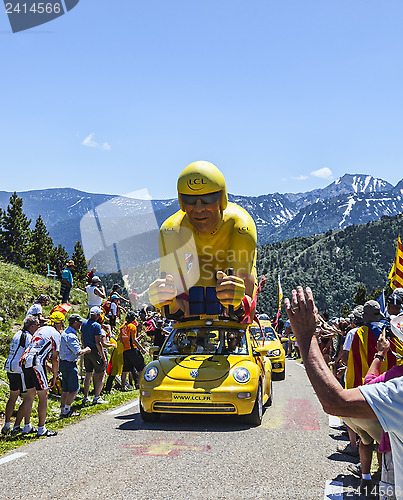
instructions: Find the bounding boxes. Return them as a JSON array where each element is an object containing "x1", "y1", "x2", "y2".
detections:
[{"x1": 81, "y1": 306, "x2": 107, "y2": 404}]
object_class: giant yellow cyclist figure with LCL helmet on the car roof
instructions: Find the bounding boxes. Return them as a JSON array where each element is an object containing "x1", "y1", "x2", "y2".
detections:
[{"x1": 148, "y1": 161, "x2": 257, "y2": 318}]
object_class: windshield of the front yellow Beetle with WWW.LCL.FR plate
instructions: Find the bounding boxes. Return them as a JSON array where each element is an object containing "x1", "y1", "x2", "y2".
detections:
[{"x1": 160, "y1": 327, "x2": 249, "y2": 356}]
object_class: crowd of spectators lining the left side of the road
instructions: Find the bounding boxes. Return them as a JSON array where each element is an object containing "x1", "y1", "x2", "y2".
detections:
[{"x1": 1, "y1": 276, "x2": 170, "y2": 437}]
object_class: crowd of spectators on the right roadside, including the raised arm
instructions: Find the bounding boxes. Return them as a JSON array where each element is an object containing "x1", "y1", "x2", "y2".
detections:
[{"x1": 283, "y1": 288, "x2": 403, "y2": 500}]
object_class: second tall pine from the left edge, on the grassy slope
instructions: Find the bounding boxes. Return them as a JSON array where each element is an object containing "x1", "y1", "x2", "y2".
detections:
[{"x1": 27, "y1": 215, "x2": 53, "y2": 275}]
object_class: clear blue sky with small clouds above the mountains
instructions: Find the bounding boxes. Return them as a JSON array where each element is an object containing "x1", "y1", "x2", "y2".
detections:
[{"x1": 0, "y1": 0, "x2": 403, "y2": 198}]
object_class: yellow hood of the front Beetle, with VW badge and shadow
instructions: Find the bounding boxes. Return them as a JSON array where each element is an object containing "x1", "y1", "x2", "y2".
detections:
[{"x1": 159, "y1": 354, "x2": 240, "y2": 382}]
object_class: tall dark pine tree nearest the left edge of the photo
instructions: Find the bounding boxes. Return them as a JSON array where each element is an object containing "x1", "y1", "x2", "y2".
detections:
[{"x1": 0, "y1": 191, "x2": 31, "y2": 267}]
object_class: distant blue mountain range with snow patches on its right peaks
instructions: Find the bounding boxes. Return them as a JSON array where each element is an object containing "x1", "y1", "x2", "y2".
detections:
[{"x1": 0, "y1": 174, "x2": 403, "y2": 255}]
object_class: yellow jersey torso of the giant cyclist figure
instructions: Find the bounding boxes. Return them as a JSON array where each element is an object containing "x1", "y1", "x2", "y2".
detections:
[{"x1": 159, "y1": 203, "x2": 257, "y2": 294}]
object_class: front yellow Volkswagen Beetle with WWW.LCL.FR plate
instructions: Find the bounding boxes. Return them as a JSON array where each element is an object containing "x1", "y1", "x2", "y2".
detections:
[{"x1": 140, "y1": 319, "x2": 272, "y2": 426}]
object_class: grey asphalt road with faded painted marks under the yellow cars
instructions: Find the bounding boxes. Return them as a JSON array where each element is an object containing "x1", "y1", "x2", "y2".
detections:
[{"x1": 0, "y1": 360, "x2": 364, "y2": 500}]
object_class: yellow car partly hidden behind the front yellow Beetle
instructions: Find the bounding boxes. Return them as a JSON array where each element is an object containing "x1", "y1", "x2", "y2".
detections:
[{"x1": 250, "y1": 319, "x2": 285, "y2": 380}]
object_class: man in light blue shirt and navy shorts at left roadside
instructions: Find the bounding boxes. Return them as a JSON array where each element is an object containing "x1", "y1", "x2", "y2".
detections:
[{"x1": 59, "y1": 313, "x2": 91, "y2": 418}]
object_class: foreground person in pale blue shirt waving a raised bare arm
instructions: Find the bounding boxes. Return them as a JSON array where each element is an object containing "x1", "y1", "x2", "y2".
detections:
[{"x1": 284, "y1": 286, "x2": 403, "y2": 500}]
